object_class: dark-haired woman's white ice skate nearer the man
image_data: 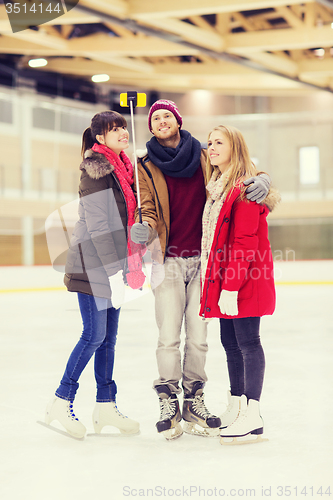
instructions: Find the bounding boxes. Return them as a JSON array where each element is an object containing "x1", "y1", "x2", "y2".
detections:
[{"x1": 93, "y1": 401, "x2": 140, "y2": 436}]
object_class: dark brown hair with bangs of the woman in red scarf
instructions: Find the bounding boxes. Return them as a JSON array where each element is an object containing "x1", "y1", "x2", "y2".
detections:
[{"x1": 81, "y1": 111, "x2": 127, "y2": 157}]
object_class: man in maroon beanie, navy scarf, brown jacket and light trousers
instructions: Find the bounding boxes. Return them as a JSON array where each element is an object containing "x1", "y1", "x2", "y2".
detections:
[{"x1": 131, "y1": 100, "x2": 270, "y2": 439}]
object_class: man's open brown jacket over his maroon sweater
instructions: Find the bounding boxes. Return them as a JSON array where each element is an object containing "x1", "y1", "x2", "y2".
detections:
[{"x1": 135, "y1": 149, "x2": 207, "y2": 263}]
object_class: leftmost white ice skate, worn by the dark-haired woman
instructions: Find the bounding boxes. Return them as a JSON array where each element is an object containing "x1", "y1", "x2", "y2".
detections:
[{"x1": 40, "y1": 396, "x2": 86, "y2": 439}]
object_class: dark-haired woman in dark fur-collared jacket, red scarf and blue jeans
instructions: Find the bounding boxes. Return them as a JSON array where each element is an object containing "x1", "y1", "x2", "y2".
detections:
[{"x1": 45, "y1": 111, "x2": 145, "y2": 438}]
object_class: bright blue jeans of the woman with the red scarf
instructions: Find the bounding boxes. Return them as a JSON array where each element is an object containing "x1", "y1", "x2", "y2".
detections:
[{"x1": 56, "y1": 293, "x2": 120, "y2": 403}]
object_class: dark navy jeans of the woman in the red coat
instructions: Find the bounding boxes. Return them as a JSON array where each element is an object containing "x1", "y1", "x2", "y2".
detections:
[{"x1": 220, "y1": 317, "x2": 265, "y2": 401}]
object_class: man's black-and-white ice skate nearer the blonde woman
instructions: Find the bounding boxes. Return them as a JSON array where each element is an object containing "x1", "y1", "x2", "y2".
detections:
[{"x1": 183, "y1": 382, "x2": 221, "y2": 437}]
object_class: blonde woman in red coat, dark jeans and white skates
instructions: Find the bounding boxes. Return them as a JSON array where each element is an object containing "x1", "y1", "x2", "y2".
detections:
[{"x1": 200, "y1": 126, "x2": 279, "y2": 444}]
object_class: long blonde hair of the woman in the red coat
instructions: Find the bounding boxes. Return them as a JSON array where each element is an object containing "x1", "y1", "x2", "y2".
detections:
[{"x1": 206, "y1": 125, "x2": 259, "y2": 198}]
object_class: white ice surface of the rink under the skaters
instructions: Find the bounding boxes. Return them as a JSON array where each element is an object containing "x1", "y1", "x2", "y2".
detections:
[{"x1": 0, "y1": 261, "x2": 333, "y2": 500}]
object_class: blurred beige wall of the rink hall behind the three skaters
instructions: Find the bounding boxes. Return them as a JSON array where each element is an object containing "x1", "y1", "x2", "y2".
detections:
[{"x1": 0, "y1": 88, "x2": 333, "y2": 265}]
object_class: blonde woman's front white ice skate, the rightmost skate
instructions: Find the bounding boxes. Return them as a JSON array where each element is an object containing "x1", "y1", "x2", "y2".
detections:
[{"x1": 220, "y1": 394, "x2": 267, "y2": 445}]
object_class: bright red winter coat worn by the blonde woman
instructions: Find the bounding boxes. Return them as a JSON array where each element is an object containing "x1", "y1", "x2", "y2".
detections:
[{"x1": 199, "y1": 188, "x2": 278, "y2": 319}]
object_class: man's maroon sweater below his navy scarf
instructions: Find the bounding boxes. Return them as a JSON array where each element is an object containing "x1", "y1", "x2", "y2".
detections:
[{"x1": 165, "y1": 166, "x2": 206, "y2": 257}]
